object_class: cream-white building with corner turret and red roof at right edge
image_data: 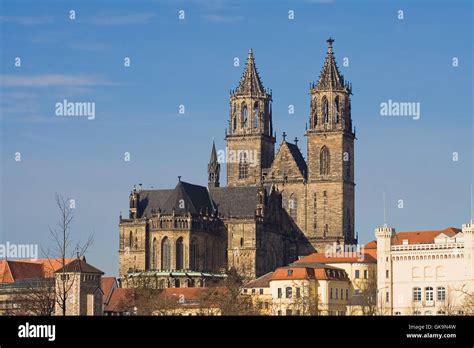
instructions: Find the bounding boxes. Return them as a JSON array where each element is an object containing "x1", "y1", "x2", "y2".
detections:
[{"x1": 375, "y1": 221, "x2": 474, "y2": 315}]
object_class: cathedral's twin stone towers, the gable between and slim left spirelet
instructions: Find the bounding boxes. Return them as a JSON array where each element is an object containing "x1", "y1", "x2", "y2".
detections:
[{"x1": 215, "y1": 38, "x2": 356, "y2": 252}]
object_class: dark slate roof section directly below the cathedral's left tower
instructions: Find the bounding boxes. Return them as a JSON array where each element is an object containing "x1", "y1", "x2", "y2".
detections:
[{"x1": 209, "y1": 186, "x2": 258, "y2": 217}]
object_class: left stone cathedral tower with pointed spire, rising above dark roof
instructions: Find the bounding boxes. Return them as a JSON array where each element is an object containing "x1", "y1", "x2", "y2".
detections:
[{"x1": 226, "y1": 49, "x2": 275, "y2": 186}]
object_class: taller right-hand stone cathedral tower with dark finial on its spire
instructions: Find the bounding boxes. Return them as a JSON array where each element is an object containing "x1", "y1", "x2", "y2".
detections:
[{"x1": 306, "y1": 38, "x2": 355, "y2": 252}]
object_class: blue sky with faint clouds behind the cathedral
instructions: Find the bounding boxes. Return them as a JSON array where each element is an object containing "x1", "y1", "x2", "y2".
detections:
[{"x1": 0, "y1": 0, "x2": 474, "y2": 274}]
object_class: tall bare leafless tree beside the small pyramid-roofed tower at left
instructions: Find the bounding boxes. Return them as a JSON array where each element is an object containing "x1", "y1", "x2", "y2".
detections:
[{"x1": 47, "y1": 193, "x2": 94, "y2": 315}]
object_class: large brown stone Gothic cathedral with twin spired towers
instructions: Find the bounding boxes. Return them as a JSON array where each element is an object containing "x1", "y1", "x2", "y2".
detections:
[{"x1": 119, "y1": 39, "x2": 357, "y2": 287}]
